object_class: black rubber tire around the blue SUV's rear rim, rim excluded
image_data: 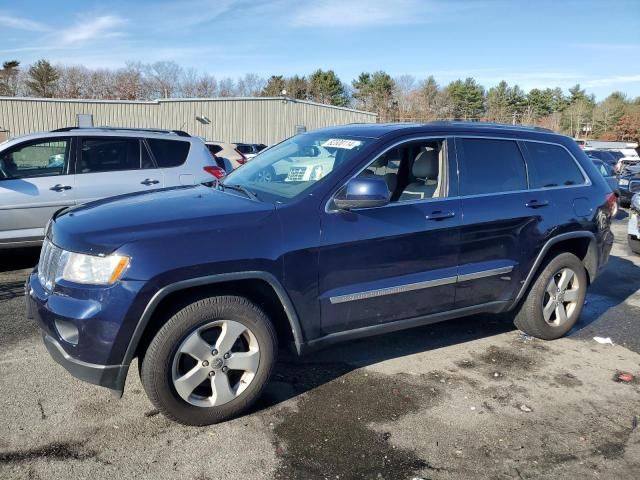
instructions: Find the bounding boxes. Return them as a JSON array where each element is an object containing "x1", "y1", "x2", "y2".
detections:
[{"x1": 514, "y1": 253, "x2": 587, "y2": 340}]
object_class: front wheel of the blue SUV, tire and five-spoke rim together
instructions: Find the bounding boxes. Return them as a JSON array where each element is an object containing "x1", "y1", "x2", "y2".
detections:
[{"x1": 141, "y1": 296, "x2": 277, "y2": 425}]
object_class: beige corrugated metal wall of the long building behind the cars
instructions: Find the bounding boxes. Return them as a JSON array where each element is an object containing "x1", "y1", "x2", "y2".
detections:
[{"x1": 0, "y1": 97, "x2": 376, "y2": 144}]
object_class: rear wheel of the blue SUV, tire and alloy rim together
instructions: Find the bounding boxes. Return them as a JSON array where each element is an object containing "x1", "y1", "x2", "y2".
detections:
[{"x1": 514, "y1": 253, "x2": 587, "y2": 340}]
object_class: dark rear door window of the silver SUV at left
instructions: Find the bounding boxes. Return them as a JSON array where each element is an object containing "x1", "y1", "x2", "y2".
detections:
[{"x1": 76, "y1": 137, "x2": 143, "y2": 173}]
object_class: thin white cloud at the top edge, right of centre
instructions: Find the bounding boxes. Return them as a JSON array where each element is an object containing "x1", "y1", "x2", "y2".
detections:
[{"x1": 291, "y1": 0, "x2": 460, "y2": 27}]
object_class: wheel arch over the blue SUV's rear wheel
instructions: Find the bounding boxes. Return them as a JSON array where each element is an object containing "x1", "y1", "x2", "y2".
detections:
[{"x1": 511, "y1": 230, "x2": 598, "y2": 307}]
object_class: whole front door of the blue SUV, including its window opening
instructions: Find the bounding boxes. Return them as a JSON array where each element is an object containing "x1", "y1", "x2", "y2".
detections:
[{"x1": 319, "y1": 139, "x2": 461, "y2": 334}]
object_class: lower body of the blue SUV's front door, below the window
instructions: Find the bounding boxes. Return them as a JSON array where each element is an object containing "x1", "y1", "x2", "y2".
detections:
[{"x1": 320, "y1": 199, "x2": 460, "y2": 333}]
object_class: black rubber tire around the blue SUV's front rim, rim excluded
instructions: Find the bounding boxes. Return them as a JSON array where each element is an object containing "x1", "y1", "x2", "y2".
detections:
[{"x1": 140, "y1": 296, "x2": 278, "y2": 425}]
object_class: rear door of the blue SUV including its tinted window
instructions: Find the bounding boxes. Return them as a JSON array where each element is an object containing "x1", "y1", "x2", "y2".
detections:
[{"x1": 456, "y1": 137, "x2": 550, "y2": 308}]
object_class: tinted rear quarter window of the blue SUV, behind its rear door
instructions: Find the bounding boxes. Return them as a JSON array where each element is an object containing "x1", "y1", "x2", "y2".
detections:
[{"x1": 523, "y1": 141, "x2": 585, "y2": 188}]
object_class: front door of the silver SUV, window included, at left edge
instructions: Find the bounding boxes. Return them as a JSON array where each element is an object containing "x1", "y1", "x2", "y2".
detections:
[{"x1": 0, "y1": 138, "x2": 75, "y2": 243}]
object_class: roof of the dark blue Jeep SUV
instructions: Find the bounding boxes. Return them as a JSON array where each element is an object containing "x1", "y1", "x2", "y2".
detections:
[{"x1": 314, "y1": 120, "x2": 558, "y2": 138}]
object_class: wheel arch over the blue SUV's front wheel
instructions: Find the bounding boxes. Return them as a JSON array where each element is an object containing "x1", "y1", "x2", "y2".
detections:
[{"x1": 122, "y1": 271, "x2": 304, "y2": 365}]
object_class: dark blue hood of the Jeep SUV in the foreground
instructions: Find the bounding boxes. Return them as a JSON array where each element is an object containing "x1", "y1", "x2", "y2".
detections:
[{"x1": 52, "y1": 185, "x2": 275, "y2": 254}]
